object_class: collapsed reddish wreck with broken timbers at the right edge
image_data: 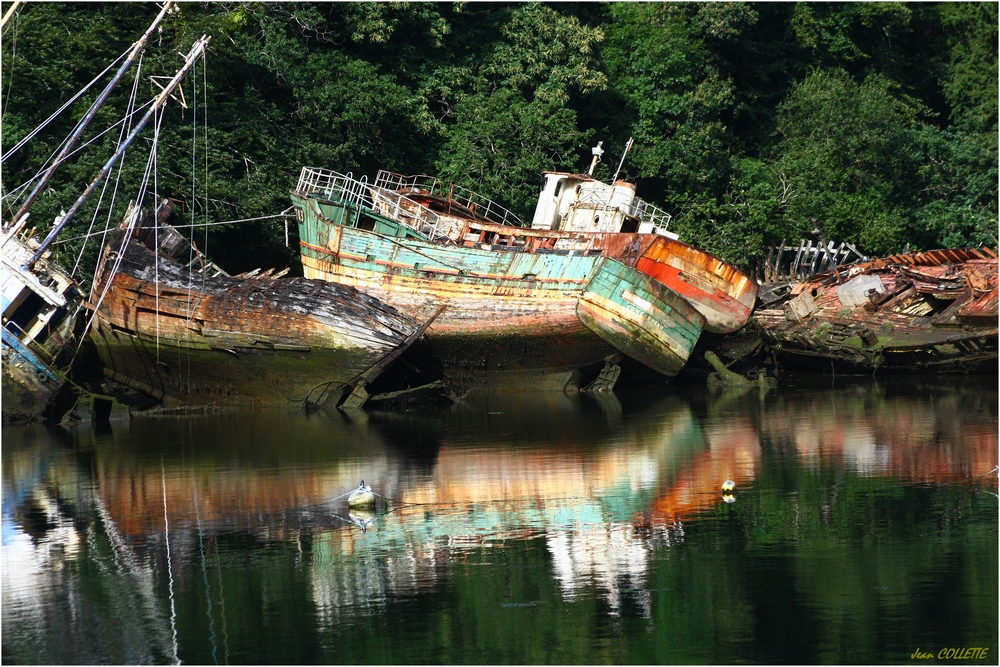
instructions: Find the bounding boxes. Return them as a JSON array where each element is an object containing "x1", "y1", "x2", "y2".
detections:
[{"x1": 754, "y1": 248, "x2": 997, "y2": 373}]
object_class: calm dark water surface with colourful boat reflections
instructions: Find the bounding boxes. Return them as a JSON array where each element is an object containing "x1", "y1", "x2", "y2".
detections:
[{"x1": 2, "y1": 377, "x2": 998, "y2": 665}]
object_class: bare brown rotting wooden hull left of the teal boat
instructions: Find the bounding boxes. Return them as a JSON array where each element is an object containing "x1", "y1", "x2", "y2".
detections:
[{"x1": 90, "y1": 202, "x2": 426, "y2": 408}]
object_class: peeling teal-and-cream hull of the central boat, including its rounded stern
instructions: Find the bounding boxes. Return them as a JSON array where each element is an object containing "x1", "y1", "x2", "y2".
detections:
[{"x1": 292, "y1": 189, "x2": 704, "y2": 390}]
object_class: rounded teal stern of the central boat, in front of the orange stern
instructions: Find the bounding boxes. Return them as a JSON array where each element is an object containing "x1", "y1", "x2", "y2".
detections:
[{"x1": 577, "y1": 258, "x2": 705, "y2": 376}]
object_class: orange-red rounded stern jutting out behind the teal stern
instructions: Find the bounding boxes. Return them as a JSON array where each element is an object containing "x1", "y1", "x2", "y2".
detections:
[{"x1": 635, "y1": 236, "x2": 758, "y2": 333}]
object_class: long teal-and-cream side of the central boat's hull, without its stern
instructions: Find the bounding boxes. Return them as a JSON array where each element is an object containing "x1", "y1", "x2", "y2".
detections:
[{"x1": 301, "y1": 221, "x2": 616, "y2": 390}]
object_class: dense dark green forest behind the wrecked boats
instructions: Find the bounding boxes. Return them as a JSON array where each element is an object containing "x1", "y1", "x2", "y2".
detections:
[{"x1": 2, "y1": 2, "x2": 998, "y2": 280}]
